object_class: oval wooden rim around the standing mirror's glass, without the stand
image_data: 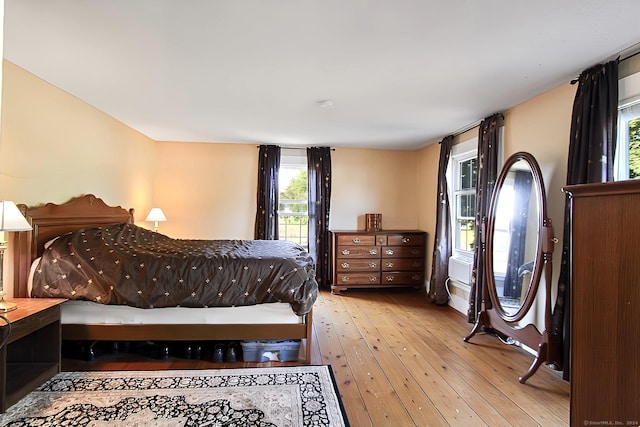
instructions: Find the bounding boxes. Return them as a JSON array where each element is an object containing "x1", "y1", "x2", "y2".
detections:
[{"x1": 484, "y1": 152, "x2": 547, "y2": 322}]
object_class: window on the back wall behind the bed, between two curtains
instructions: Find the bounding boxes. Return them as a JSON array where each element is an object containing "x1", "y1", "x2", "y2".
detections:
[{"x1": 278, "y1": 148, "x2": 309, "y2": 249}]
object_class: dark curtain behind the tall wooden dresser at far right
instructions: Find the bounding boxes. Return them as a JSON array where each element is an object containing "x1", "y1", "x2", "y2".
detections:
[{"x1": 551, "y1": 60, "x2": 618, "y2": 380}]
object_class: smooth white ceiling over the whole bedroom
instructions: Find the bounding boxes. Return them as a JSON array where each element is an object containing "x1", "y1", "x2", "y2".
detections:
[{"x1": 4, "y1": 0, "x2": 640, "y2": 149}]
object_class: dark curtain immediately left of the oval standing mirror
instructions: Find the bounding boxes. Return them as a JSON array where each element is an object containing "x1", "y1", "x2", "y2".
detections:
[{"x1": 467, "y1": 113, "x2": 502, "y2": 323}]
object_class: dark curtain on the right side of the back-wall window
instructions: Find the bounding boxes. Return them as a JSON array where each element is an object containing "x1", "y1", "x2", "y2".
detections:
[{"x1": 307, "y1": 147, "x2": 331, "y2": 288}]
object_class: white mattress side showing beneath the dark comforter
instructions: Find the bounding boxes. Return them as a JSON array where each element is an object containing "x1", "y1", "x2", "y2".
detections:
[{"x1": 60, "y1": 301, "x2": 304, "y2": 325}]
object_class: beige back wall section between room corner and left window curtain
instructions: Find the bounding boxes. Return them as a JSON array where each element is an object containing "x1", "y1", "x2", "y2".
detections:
[{"x1": 154, "y1": 142, "x2": 258, "y2": 239}]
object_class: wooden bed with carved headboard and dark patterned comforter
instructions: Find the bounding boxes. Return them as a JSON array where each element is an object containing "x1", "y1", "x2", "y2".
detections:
[{"x1": 12, "y1": 194, "x2": 318, "y2": 363}]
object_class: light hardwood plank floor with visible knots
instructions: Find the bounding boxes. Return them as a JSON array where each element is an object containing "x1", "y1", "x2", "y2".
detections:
[{"x1": 63, "y1": 290, "x2": 569, "y2": 427}]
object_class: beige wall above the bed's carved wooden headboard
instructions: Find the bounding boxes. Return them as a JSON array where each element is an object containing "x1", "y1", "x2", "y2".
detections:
[{"x1": 0, "y1": 61, "x2": 156, "y2": 208}]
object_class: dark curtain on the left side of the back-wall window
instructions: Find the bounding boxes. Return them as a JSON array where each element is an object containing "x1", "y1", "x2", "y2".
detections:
[{"x1": 255, "y1": 145, "x2": 280, "y2": 240}]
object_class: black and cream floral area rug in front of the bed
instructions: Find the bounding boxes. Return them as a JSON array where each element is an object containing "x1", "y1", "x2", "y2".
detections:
[{"x1": 0, "y1": 366, "x2": 349, "y2": 427}]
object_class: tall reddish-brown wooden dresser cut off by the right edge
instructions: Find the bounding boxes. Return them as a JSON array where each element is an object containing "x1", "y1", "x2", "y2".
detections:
[{"x1": 564, "y1": 181, "x2": 640, "y2": 426}]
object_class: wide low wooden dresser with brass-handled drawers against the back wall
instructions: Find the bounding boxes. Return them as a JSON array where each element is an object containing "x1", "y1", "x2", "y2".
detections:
[{"x1": 331, "y1": 230, "x2": 427, "y2": 294}]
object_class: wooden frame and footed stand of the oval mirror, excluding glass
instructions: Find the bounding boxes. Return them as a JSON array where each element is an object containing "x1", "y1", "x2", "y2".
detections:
[{"x1": 464, "y1": 152, "x2": 560, "y2": 384}]
